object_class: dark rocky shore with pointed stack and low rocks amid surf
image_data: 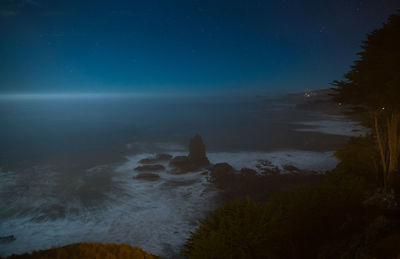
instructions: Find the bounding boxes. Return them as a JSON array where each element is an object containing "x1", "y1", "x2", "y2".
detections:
[{"x1": 134, "y1": 135, "x2": 322, "y2": 203}]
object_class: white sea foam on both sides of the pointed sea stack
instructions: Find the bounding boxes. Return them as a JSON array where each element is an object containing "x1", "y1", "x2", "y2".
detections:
[{"x1": 0, "y1": 150, "x2": 337, "y2": 256}]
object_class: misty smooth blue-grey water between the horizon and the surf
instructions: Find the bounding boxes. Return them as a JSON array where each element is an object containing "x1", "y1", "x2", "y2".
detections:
[{"x1": 0, "y1": 96, "x2": 344, "y2": 166}]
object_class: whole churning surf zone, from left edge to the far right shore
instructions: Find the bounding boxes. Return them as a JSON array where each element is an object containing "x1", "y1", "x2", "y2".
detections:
[{"x1": 0, "y1": 91, "x2": 368, "y2": 257}]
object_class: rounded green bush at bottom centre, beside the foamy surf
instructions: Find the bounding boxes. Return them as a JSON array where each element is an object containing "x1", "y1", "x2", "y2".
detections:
[{"x1": 182, "y1": 199, "x2": 269, "y2": 258}]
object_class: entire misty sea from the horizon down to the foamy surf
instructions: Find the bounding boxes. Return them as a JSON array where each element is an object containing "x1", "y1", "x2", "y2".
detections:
[{"x1": 0, "y1": 95, "x2": 356, "y2": 256}]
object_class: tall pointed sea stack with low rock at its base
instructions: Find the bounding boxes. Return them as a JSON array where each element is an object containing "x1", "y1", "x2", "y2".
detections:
[{"x1": 169, "y1": 135, "x2": 210, "y2": 173}]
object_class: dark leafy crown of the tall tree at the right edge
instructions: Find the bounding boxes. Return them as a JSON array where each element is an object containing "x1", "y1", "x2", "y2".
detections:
[{"x1": 333, "y1": 12, "x2": 400, "y2": 110}]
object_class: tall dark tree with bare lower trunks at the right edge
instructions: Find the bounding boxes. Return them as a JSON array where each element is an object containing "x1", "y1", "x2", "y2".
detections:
[{"x1": 332, "y1": 10, "x2": 400, "y2": 190}]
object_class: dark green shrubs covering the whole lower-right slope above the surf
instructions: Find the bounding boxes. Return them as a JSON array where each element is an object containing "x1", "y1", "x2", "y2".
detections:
[{"x1": 182, "y1": 171, "x2": 400, "y2": 258}]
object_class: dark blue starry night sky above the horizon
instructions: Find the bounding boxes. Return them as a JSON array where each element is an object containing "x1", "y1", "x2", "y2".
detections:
[{"x1": 0, "y1": 0, "x2": 400, "y2": 93}]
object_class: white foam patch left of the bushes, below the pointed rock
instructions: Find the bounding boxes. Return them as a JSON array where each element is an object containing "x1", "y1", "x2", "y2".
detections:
[{"x1": 0, "y1": 154, "x2": 217, "y2": 256}]
